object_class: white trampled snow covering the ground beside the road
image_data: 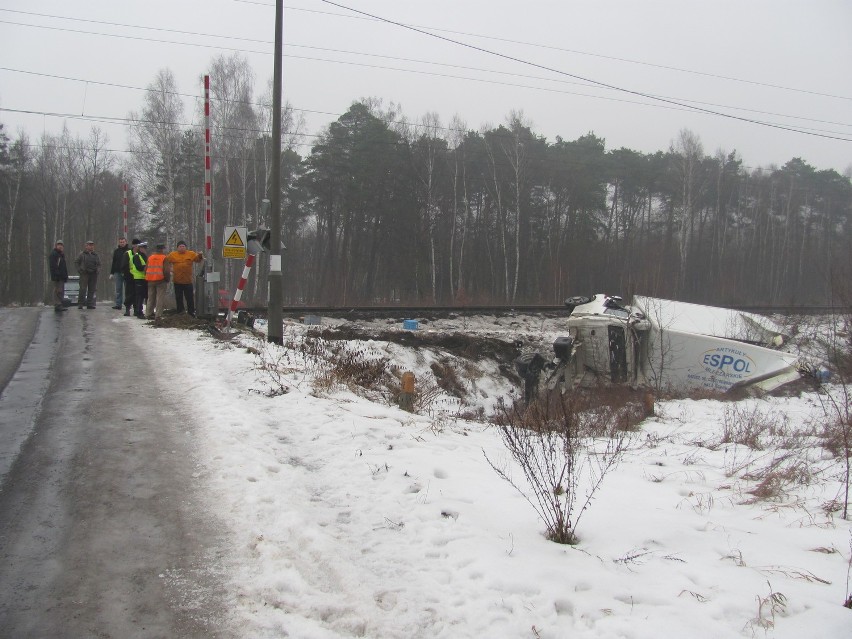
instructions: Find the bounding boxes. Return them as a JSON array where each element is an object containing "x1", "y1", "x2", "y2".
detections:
[{"x1": 128, "y1": 317, "x2": 852, "y2": 639}]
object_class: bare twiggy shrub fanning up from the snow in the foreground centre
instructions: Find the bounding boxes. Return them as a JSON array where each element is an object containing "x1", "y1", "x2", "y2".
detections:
[{"x1": 485, "y1": 394, "x2": 630, "y2": 544}]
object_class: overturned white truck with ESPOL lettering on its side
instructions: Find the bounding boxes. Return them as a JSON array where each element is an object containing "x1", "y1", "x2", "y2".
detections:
[{"x1": 515, "y1": 294, "x2": 799, "y2": 401}]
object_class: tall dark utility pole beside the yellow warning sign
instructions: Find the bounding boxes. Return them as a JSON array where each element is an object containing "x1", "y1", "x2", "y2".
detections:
[{"x1": 266, "y1": 0, "x2": 284, "y2": 344}]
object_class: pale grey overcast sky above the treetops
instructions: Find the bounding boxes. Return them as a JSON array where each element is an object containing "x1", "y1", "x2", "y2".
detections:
[{"x1": 0, "y1": 0, "x2": 852, "y2": 173}]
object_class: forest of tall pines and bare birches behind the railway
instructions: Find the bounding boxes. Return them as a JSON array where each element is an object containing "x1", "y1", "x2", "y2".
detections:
[{"x1": 0, "y1": 57, "x2": 852, "y2": 306}]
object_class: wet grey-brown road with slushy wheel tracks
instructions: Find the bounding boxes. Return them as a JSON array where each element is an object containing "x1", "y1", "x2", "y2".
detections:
[{"x1": 0, "y1": 305, "x2": 236, "y2": 638}]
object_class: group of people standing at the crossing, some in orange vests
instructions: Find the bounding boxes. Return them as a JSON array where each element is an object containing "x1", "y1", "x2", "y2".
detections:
[{"x1": 48, "y1": 237, "x2": 204, "y2": 320}]
